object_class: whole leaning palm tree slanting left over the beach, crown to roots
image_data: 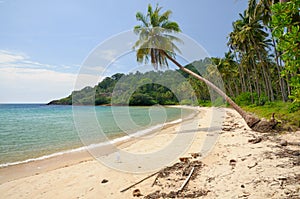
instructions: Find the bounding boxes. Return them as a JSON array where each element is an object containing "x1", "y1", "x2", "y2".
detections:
[{"x1": 133, "y1": 4, "x2": 276, "y2": 132}]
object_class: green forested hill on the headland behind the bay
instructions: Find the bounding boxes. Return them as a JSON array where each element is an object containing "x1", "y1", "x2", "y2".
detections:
[{"x1": 48, "y1": 59, "x2": 211, "y2": 105}]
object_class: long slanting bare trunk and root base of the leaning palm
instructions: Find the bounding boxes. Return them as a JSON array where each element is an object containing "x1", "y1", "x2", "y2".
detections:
[{"x1": 161, "y1": 50, "x2": 277, "y2": 132}]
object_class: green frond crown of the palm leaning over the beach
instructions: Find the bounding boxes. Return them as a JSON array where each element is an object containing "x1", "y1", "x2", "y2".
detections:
[{"x1": 133, "y1": 4, "x2": 181, "y2": 69}]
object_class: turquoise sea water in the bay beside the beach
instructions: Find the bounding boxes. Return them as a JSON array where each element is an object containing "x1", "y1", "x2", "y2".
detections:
[{"x1": 0, "y1": 104, "x2": 192, "y2": 167}]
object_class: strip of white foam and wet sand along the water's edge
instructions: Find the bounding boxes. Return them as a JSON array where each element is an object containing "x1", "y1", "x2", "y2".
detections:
[{"x1": 0, "y1": 105, "x2": 199, "y2": 185}]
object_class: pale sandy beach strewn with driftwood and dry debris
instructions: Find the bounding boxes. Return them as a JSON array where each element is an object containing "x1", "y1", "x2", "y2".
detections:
[{"x1": 0, "y1": 107, "x2": 300, "y2": 199}]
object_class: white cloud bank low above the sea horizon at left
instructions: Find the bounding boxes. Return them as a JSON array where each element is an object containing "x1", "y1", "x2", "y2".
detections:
[{"x1": 0, "y1": 50, "x2": 99, "y2": 103}]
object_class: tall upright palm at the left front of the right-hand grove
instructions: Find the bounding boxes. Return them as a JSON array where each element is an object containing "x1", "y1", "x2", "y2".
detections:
[{"x1": 228, "y1": 5, "x2": 274, "y2": 101}]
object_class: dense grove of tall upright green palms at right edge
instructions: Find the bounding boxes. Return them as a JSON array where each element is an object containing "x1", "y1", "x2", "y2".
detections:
[{"x1": 226, "y1": 0, "x2": 300, "y2": 107}]
